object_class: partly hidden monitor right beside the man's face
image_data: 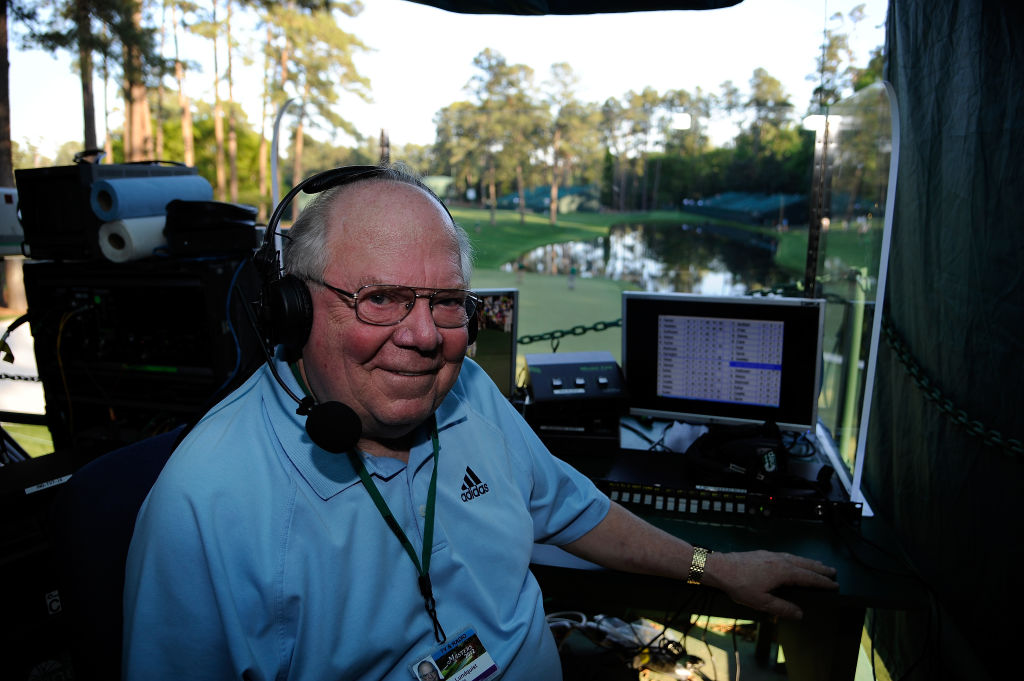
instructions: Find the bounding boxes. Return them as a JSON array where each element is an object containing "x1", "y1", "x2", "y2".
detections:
[{"x1": 467, "y1": 289, "x2": 519, "y2": 397}]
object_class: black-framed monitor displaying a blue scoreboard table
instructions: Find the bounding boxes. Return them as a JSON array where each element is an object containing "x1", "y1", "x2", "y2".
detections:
[{"x1": 623, "y1": 291, "x2": 824, "y2": 430}]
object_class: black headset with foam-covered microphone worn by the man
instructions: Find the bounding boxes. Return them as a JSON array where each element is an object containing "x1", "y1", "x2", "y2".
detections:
[{"x1": 253, "y1": 166, "x2": 478, "y2": 454}]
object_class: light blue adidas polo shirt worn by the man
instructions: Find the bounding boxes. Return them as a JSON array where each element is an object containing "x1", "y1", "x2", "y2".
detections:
[{"x1": 124, "y1": 359, "x2": 609, "y2": 681}]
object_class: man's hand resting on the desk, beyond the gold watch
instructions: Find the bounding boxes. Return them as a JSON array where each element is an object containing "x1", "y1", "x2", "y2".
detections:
[{"x1": 703, "y1": 551, "x2": 839, "y2": 620}]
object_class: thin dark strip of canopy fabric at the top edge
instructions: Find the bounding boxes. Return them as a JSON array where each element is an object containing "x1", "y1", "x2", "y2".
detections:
[{"x1": 412, "y1": 0, "x2": 741, "y2": 15}]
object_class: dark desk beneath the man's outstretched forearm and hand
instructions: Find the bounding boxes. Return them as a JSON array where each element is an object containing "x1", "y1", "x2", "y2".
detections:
[{"x1": 532, "y1": 517, "x2": 925, "y2": 681}]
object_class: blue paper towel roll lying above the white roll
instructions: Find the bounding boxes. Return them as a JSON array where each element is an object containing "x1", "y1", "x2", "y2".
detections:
[{"x1": 89, "y1": 175, "x2": 213, "y2": 222}]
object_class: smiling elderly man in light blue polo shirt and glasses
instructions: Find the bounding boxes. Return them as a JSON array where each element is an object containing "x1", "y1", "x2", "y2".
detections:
[{"x1": 124, "y1": 169, "x2": 835, "y2": 681}]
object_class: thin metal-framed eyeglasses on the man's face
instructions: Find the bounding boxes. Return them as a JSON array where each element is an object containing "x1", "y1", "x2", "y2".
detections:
[{"x1": 311, "y1": 280, "x2": 480, "y2": 329}]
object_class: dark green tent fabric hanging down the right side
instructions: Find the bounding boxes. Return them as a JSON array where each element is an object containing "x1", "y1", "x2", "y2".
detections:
[{"x1": 864, "y1": 0, "x2": 1024, "y2": 679}]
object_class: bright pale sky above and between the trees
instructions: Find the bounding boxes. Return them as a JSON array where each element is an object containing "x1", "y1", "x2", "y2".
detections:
[{"x1": 9, "y1": 0, "x2": 888, "y2": 160}]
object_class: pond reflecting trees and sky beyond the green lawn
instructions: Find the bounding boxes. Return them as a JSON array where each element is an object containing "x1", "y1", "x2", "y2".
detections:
[{"x1": 505, "y1": 222, "x2": 794, "y2": 296}]
